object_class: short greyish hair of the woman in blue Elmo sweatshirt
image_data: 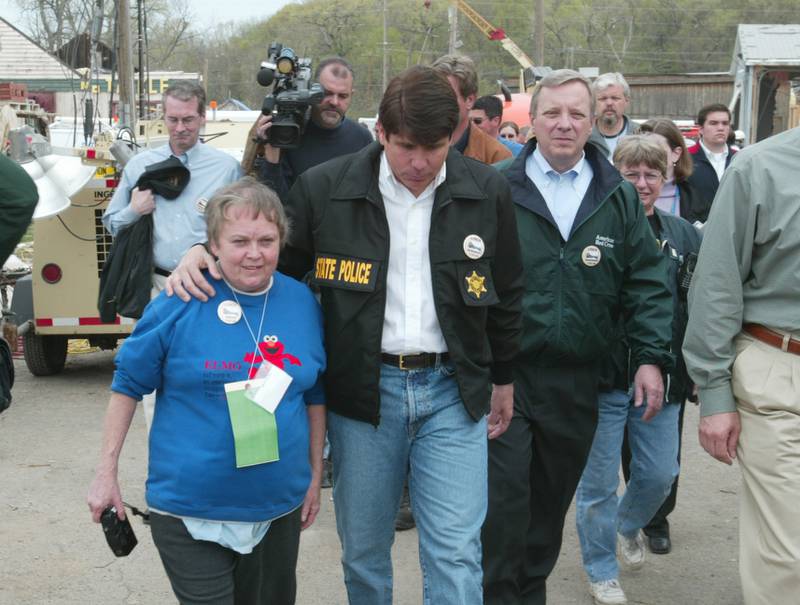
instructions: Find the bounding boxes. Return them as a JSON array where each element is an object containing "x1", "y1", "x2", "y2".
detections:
[{"x1": 205, "y1": 176, "x2": 289, "y2": 248}]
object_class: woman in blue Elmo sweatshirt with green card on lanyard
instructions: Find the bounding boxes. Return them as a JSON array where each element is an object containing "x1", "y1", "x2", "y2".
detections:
[{"x1": 88, "y1": 178, "x2": 325, "y2": 605}]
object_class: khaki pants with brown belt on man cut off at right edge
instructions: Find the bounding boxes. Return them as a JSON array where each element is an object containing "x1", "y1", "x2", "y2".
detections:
[{"x1": 732, "y1": 334, "x2": 800, "y2": 605}]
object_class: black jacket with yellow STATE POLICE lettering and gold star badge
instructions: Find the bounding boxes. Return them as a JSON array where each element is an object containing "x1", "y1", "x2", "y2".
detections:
[{"x1": 280, "y1": 143, "x2": 522, "y2": 425}]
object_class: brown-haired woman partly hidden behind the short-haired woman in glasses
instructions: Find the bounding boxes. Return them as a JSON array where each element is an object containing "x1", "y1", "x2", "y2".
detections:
[{"x1": 639, "y1": 118, "x2": 710, "y2": 227}]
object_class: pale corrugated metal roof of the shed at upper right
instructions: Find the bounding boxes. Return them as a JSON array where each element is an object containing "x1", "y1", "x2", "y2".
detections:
[{"x1": 736, "y1": 24, "x2": 800, "y2": 65}]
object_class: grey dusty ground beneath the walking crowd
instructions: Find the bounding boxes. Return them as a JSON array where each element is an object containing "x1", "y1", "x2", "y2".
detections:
[{"x1": 0, "y1": 353, "x2": 742, "y2": 605}]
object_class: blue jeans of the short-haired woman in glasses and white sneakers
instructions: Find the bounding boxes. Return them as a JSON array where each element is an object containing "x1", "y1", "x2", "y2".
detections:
[{"x1": 575, "y1": 390, "x2": 680, "y2": 582}]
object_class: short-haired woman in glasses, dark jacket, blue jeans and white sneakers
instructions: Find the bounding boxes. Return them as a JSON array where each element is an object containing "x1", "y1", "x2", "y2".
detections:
[{"x1": 575, "y1": 135, "x2": 700, "y2": 604}]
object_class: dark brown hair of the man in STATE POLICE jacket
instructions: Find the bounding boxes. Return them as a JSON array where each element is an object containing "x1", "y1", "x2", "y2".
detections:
[{"x1": 378, "y1": 65, "x2": 459, "y2": 146}]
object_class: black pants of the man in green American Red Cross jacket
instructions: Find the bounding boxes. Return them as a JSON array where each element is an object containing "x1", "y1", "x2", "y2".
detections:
[{"x1": 481, "y1": 363, "x2": 598, "y2": 605}]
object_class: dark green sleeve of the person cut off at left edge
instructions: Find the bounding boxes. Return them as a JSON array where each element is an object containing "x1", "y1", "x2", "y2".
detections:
[{"x1": 0, "y1": 153, "x2": 39, "y2": 267}]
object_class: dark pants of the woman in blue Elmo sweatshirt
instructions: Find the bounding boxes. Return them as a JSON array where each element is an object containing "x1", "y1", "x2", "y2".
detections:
[{"x1": 150, "y1": 508, "x2": 300, "y2": 605}]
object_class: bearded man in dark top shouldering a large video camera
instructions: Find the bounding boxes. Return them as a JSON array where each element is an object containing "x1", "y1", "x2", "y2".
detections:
[{"x1": 242, "y1": 57, "x2": 372, "y2": 200}]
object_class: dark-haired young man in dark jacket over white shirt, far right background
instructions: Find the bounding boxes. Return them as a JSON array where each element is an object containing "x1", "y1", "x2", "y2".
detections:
[{"x1": 689, "y1": 103, "x2": 736, "y2": 222}]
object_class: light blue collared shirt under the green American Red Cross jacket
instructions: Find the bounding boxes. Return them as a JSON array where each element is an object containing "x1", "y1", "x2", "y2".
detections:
[{"x1": 525, "y1": 147, "x2": 594, "y2": 241}]
